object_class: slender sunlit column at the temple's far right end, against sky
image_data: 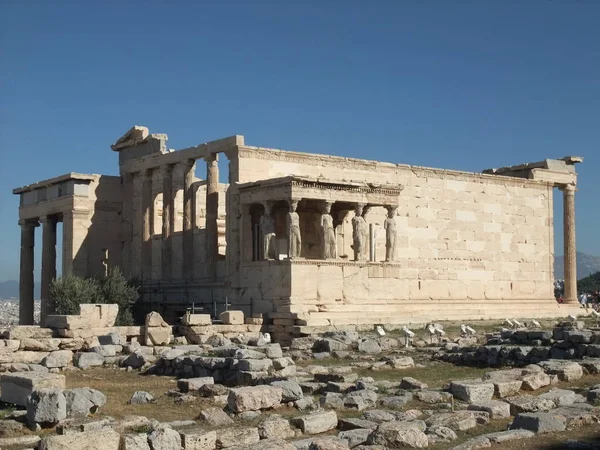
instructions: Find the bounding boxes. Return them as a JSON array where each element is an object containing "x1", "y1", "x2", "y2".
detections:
[{"x1": 561, "y1": 184, "x2": 577, "y2": 303}]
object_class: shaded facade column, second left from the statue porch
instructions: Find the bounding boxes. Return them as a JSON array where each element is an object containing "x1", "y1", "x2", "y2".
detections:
[{"x1": 182, "y1": 159, "x2": 196, "y2": 280}]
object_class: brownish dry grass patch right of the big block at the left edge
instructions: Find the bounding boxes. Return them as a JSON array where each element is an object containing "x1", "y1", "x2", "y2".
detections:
[{"x1": 66, "y1": 368, "x2": 212, "y2": 422}]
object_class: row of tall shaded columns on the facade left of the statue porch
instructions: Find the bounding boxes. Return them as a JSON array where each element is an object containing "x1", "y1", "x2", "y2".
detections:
[{"x1": 123, "y1": 154, "x2": 219, "y2": 280}]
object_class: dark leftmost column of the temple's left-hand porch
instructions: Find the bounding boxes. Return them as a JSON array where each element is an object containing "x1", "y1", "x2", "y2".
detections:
[{"x1": 19, "y1": 220, "x2": 38, "y2": 325}]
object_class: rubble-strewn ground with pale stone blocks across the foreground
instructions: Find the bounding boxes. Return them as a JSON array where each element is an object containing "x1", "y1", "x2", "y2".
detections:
[{"x1": 0, "y1": 323, "x2": 600, "y2": 450}]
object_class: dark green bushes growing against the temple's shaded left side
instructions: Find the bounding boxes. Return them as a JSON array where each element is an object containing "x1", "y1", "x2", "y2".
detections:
[{"x1": 50, "y1": 267, "x2": 139, "y2": 326}]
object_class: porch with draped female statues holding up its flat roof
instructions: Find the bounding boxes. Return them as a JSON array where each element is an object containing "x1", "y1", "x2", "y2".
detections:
[{"x1": 239, "y1": 176, "x2": 402, "y2": 262}]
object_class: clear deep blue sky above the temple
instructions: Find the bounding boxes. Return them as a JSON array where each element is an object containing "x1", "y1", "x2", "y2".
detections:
[{"x1": 0, "y1": 0, "x2": 600, "y2": 280}]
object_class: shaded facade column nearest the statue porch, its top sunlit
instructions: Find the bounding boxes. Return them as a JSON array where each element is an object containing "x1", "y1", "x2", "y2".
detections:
[{"x1": 205, "y1": 153, "x2": 219, "y2": 279}]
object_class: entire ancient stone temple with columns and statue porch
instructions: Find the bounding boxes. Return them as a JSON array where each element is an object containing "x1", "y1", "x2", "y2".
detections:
[{"x1": 13, "y1": 126, "x2": 582, "y2": 340}]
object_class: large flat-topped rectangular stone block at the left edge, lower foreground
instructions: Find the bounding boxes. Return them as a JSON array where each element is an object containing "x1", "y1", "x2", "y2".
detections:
[{"x1": 0, "y1": 371, "x2": 66, "y2": 406}]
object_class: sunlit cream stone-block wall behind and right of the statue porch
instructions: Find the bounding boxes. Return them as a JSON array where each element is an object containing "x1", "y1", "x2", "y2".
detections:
[{"x1": 229, "y1": 147, "x2": 559, "y2": 323}]
